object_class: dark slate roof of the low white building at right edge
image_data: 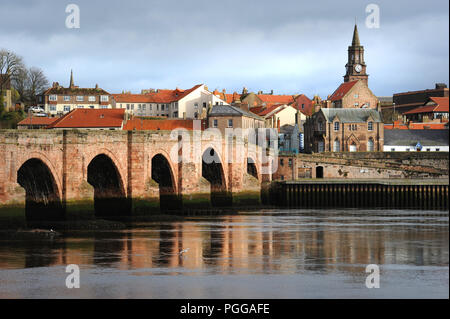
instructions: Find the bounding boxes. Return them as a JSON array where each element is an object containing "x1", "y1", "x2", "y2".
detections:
[{"x1": 384, "y1": 129, "x2": 448, "y2": 146}]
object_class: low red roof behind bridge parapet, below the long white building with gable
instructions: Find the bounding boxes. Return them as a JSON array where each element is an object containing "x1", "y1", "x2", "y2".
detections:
[{"x1": 123, "y1": 118, "x2": 206, "y2": 131}]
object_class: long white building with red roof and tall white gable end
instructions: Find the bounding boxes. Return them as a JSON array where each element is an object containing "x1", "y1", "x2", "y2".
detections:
[{"x1": 112, "y1": 84, "x2": 228, "y2": 119}]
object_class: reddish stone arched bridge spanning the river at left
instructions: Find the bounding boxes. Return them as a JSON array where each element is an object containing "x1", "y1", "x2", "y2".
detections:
[{"x1": 0, "y1": 130, "x2": 271, "y2": 220}]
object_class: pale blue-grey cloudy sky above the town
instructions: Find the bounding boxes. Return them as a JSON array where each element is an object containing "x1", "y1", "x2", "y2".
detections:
[{"x1": 0, "y1": 0, "x2": 449, "y2": 97}]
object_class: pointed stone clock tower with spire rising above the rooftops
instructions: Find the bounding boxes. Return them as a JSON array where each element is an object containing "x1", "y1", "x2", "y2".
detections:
[{"x1": 344, "y1": 24, "x2": 369, "y2": 85}]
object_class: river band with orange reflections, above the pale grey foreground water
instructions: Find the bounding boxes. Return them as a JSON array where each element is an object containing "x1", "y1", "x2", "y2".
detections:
[{"x1": 0, "y1": 210, "x2": 449, "y2": 279}]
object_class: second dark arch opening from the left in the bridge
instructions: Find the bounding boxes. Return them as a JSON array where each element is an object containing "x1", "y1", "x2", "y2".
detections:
[{"x1": 87, "y1": 154, "x2": 129, "y2": 217}]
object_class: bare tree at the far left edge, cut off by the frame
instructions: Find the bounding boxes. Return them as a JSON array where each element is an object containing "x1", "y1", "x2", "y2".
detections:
[{"x1": 0, "y1": 49, "x2": 25, "y2": 113}]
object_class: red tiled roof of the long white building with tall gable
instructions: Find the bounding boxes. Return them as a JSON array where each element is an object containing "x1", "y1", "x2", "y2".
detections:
[{"x1": 112, "y1": 84, "x2": 203, "y2": 103}]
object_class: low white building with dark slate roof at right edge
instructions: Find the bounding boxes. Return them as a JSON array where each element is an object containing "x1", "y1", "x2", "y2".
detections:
[{"x1": 384, "y1": 129, "x2": 448, "y2": 152}]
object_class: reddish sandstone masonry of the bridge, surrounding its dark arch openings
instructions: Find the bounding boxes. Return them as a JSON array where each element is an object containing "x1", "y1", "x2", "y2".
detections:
[{"x1": 0, "y1": 130, "x2": 262, "y2": 208}]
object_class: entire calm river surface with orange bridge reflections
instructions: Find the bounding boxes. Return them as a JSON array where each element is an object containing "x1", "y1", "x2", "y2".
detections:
[{"x1": 0, "y1": 210, "x2": 449, "y2": 298}]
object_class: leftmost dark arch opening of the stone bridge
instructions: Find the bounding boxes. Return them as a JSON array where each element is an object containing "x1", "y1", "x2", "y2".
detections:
[{"x1": 17, "y1": 157, "x2": 64, "y2": 221}]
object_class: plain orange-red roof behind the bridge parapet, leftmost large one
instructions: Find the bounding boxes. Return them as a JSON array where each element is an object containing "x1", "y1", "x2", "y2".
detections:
[{"x1": 48, "y1": 109, "x2": 125, "y2": 128}]
